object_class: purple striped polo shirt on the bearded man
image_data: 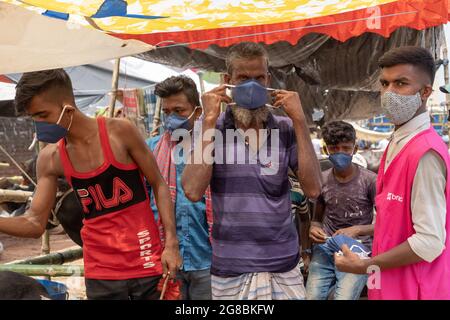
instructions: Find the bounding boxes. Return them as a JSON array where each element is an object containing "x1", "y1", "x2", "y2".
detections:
[{"x1": 210, "y1": 108, "x2": 300, "y2": 277}]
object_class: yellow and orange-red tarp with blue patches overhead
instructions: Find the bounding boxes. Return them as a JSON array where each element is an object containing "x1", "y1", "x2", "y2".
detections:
[{"x1": 3, "y1": 0, "x2": 449, "y2": 48}]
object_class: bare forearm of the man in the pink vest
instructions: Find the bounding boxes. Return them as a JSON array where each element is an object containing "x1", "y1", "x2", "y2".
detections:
[{"x1": 363, "y1": 241, "x2": 424, "y2": 273}]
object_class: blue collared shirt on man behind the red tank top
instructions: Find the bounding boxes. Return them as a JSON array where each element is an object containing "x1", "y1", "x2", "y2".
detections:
[{"x1": 147, "y1": 135, "x2": 211, "y2": 271}]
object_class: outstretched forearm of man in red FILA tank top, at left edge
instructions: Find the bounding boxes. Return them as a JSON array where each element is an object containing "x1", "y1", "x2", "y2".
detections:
[{"x1": 0, "y1": 213, "x2": 45, "y2": 238}]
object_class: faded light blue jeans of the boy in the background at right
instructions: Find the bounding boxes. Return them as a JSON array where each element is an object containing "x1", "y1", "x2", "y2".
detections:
[{"x1": 306, "y1": 245, "x2": 368, "y2": 300}]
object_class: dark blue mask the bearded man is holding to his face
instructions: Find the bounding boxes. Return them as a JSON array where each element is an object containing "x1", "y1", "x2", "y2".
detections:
[{"x1": 231, "y1": 79, "x2": 268, "y2": 110}]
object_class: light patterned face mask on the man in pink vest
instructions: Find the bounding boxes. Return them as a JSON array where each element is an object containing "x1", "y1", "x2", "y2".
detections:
[{"x1": 381, "y1": 91, "x2": 422, "y2": 126}]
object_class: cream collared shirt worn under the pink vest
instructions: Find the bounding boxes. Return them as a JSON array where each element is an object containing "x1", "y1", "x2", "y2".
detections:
[{"x1": 385, "y1": 112, "x2": 447, "y2": 262}]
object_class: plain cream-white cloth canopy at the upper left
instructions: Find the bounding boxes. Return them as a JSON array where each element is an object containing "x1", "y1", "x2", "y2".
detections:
[{"x1": 0, "y1": 2, "x2": 153, "y2": 74}]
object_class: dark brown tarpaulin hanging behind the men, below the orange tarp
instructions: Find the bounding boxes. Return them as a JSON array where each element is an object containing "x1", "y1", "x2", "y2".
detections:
[{"x1": 137, "y1": 26, "x2": 444, "y2": 122}]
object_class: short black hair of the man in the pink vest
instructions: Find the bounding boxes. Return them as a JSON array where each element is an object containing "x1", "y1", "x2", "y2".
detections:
[{"x1": 378, "y1": 46, "x2": 436, "y2": 84}]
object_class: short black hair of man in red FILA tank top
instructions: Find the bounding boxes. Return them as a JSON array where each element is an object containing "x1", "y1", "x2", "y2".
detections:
[{"x1": 14, "y1": 69, "x2": 73, "y2": 115}]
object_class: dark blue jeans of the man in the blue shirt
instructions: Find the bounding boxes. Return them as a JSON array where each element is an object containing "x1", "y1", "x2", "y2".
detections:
[{"x1": 177, "y1": 269, "x2": 212, "y2": 300}]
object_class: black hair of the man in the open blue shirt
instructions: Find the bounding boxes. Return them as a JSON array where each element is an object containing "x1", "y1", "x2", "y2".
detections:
[{"x1": 155, "y1": 76, "x2": 200, "y2": 107}]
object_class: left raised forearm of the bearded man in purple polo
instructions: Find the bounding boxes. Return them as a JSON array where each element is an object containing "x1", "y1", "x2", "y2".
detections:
[{"x1": 181, "y1": 121, "x2": 216, "y2": 202}]
